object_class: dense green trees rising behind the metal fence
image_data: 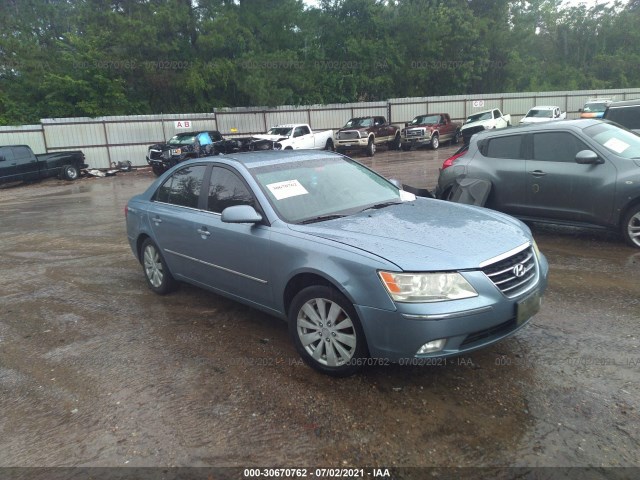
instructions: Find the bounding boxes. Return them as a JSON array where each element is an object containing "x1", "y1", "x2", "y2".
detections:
[{"x1": 0, "y1": 0, "x2": 640, "y2": 125}]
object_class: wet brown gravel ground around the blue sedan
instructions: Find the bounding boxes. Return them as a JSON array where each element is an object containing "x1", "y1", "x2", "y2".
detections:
[{"x1": 0, "y1": 147, "x2": 640, "y2": 478}]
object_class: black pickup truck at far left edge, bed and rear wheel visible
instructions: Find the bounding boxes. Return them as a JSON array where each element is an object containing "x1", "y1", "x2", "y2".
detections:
[{"x1": 0, "y1": 145, "x2": 88, "y2": 183}]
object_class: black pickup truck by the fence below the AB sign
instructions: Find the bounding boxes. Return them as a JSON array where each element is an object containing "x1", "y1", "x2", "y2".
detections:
[{"x1": 147, "y1": 130, "x2": 273, "y2": 175}]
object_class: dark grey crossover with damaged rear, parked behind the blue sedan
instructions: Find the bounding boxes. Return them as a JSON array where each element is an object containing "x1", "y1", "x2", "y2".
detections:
[{"x1": 436, "y1": 119, "x2": 640, "y2": 248}]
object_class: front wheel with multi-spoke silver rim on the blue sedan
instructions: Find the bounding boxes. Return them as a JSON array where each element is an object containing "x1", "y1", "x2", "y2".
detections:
[{"x1": 289, "y1": 286, "x2": 368, "y2": 377}]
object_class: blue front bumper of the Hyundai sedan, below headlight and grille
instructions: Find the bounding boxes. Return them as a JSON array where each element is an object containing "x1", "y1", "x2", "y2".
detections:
[{"x1": 355, "y1": 255, "x2": 549, "y2": 364}]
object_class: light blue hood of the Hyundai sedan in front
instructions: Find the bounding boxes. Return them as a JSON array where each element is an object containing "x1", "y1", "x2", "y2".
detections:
[{"x1": 290, "y1": 198, "x2": 531, "y2": 271}]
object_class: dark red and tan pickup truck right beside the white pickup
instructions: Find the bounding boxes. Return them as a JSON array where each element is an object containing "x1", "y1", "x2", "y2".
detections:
[{"x1": 336, "y1": 117, "x2": 400, "y2": 157}]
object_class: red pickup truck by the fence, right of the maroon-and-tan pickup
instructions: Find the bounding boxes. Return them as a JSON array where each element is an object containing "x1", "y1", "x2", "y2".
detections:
[{"x1": 400, "y1": 113, "x2": 462, "y2": 151}]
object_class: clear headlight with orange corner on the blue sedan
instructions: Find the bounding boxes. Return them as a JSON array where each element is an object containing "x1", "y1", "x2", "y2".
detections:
[{"x1": 378, "y1": 272, "x2": 478, "y2": 303}]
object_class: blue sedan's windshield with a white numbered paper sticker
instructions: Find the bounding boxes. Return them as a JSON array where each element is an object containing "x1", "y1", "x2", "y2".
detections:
[{"x1": 249, "y1": 157, "x2": 401, "y2": 223}]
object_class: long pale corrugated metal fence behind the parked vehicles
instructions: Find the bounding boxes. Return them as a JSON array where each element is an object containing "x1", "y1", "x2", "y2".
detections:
[{"x1": 0, "y1": 88, "x2": 640, "y2": 168}]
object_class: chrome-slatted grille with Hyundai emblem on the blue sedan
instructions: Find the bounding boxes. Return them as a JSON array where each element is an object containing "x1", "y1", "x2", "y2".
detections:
[{"x1": 482, "y1": 246, "x2": 538, "y2": 297}]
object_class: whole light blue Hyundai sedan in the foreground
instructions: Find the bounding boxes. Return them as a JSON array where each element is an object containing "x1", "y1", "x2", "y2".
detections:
[{"x1": 126, "y1": 151, "x2": 548, "y2": 376}]
